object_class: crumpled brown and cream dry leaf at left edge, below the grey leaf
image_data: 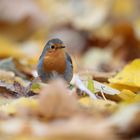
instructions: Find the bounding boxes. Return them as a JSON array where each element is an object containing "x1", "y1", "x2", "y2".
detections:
[{"x1": 0, "y1": 70, "x2": 35, "y2": 98}]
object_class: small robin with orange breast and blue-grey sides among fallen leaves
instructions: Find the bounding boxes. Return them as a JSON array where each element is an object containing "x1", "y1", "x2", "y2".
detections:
[{"x1": 37, "y1": 38, "x2": 73, "y2": 83}]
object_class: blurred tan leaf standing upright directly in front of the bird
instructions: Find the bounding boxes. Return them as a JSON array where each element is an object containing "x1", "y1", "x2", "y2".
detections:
[{"x1": 39, "y1": 80, "x2": 78, "y2": 119}]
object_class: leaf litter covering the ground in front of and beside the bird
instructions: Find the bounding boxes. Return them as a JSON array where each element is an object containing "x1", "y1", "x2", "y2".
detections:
[{"x1": 0, "y1": 41, "x2": 140, "y2": 140}]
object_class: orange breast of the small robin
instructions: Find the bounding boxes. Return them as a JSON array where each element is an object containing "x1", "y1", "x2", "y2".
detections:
[{"x1": 43, "y1": 49, "x2": 66, "y2": 74}]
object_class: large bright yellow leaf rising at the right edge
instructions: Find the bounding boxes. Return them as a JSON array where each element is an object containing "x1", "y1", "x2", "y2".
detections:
[{"x1": 109, "y1": 59, "x2": 140, "y2": 88}]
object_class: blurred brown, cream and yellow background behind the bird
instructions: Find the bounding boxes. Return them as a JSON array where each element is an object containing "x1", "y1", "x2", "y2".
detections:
[{"x1": 0, "y1": 0, "x2": 140, "y2": 75}]
